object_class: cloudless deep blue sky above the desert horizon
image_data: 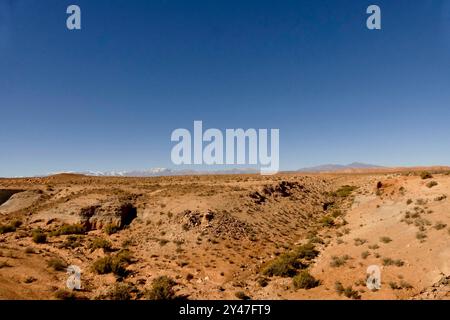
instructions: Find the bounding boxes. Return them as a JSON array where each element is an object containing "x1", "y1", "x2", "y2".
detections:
[{"x1": 0, "y1": 0, "x2": 450, "y2": 176}]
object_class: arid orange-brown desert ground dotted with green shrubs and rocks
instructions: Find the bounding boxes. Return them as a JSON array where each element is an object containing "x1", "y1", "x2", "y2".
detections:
[{"x1": 0, "y1": 168, "x2": 450, "y2": 299}]
